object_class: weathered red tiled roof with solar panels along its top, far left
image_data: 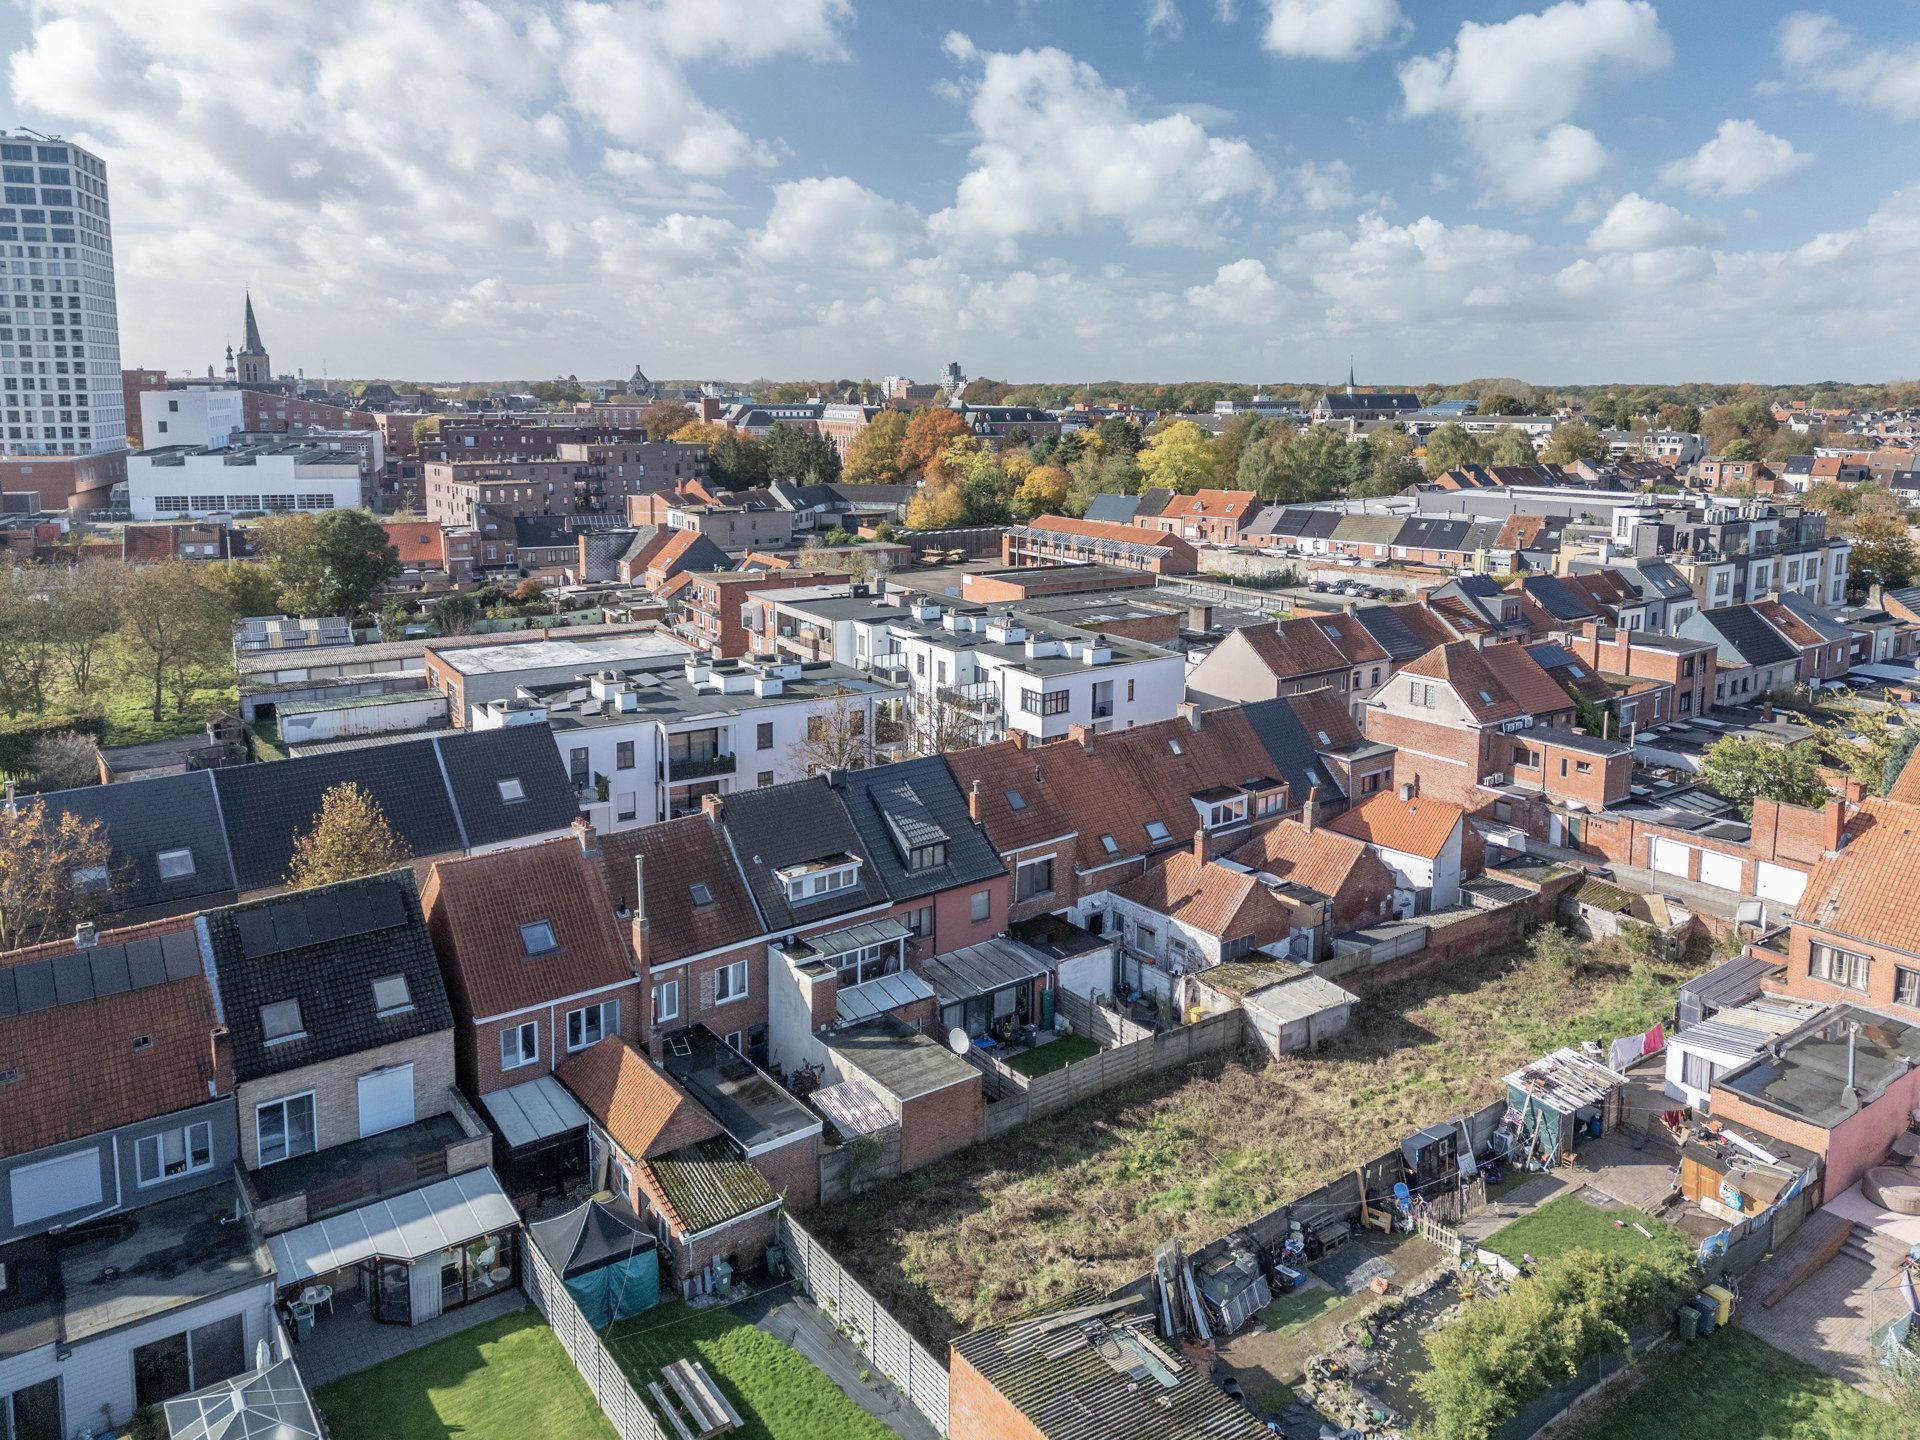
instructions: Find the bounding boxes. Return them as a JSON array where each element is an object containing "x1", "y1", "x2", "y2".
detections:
[{"x1": 0, "y1": 918, "x2": 234, "y2": 1159}]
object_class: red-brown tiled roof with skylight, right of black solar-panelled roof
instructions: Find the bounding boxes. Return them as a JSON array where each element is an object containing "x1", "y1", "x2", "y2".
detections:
[{"x1": 420, "y1": 839, "x2": 634, "y2": 1018}]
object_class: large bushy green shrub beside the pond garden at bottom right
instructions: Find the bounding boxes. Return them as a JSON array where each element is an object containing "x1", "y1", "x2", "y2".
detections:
[{"x1": 1413, "y1": 1236, "x2": 1693, "y2": 1440}]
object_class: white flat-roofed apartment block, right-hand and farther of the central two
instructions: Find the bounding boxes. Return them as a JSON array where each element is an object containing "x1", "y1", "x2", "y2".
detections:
[{"x1": 747, "y1": 588, "x2": 1187, "y2": 753}]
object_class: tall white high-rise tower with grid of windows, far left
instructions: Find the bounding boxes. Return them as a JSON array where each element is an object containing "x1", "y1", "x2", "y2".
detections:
[{"x1": 0, "y1": 131, "x2": 127, "y2": 455}]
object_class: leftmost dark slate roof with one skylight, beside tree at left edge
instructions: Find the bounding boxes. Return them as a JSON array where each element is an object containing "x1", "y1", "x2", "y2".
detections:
[{"x1": 44, "y1": 770, "x2": 238, "y2": 912}]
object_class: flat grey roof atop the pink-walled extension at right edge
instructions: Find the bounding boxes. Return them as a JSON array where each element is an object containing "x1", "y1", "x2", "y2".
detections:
[{"x1": 1715, "y1": 1004, "x2": 1920, "y2": 1129}]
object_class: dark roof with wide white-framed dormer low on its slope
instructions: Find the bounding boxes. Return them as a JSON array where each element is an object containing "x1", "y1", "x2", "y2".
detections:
[{"x1": 722, "y1": 776, "x2": 887, "y2": 931}]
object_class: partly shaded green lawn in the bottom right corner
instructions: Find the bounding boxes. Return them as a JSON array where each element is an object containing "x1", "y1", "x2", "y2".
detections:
[{"x1": 1571, "y1": 1329, "x2": 1903, "y2": 1440}]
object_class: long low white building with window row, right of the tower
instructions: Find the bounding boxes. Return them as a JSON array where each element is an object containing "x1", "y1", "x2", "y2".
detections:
[{"x1": 127, "y1": 449, "x2": 363, "y2": 520}]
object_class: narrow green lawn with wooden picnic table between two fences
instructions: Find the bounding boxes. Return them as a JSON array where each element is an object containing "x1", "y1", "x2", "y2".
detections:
[{"x1": 605, "y1": 1300, "x2": 893, "y2": 1440}]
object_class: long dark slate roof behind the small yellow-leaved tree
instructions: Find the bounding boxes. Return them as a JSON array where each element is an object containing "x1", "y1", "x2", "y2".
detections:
[{"x1": 214, "y1": 724, "x2": 580, "y2": 891}]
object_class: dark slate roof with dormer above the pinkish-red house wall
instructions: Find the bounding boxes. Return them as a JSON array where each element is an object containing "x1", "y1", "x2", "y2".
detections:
[{"x1": 839, "y1": 755, "x2": 1006, "y2": 900}]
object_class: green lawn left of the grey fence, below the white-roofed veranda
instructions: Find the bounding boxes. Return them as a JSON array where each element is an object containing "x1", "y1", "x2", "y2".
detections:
[{"x1": 315, "y1": 1308, "x2": 614, "y2": 1440}]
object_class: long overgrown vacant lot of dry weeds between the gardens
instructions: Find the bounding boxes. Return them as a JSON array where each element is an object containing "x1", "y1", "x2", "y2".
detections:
[{"x1": 806, "y1": 931, "x2": 1697, "y2": 1346}]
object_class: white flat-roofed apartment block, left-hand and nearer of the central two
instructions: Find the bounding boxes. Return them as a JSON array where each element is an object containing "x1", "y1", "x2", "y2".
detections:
[{"x1": 476, "y1": 647, "x2": 897, "y2": 831}]
